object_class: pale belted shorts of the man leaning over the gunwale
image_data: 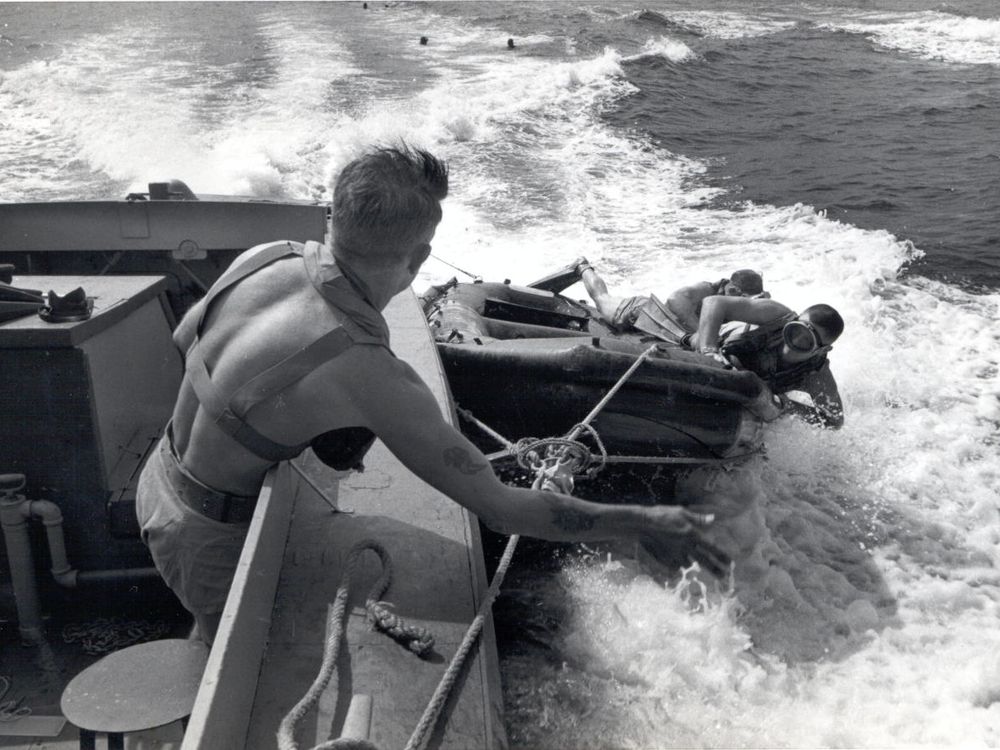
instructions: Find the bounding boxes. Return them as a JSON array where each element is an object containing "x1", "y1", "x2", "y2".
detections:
[{"x1": 135, "y1": 431, "x2": 250, "y2": 616}]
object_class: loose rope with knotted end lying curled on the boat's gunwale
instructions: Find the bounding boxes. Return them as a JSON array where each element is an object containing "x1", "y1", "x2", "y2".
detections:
[{"x1": 278, "y1": 539, "x2": 434, "y2": 750}]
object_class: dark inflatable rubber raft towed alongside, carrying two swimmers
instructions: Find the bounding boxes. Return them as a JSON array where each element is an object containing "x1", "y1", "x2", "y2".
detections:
[{"x1": 421, "y1": 280, "x2": 779, "y2": 463}]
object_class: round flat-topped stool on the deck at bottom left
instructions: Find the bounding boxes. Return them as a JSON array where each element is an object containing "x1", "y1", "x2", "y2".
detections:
[{"x1": 60, "y1": 638, "x2": 208, "y2": 750}]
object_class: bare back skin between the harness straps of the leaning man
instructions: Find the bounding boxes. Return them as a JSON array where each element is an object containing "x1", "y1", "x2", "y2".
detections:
[{"x1": 173, "y1": 244, "x2": 380, "y2": 495}]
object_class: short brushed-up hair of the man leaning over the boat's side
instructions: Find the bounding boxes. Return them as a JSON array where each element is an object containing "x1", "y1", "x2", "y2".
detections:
[{"x1": 333, "y1": 143, "x2": 448, "y2": 262}]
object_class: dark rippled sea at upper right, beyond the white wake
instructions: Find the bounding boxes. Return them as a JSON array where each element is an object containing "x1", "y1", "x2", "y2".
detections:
[{"x1": 611, "y1": 6, "x2": 1000, "y2": 289}]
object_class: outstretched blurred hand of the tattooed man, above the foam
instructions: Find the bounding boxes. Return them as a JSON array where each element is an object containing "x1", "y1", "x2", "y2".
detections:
[{"x1": 639, "y1": 505, "x2": 732, "y2": 577}]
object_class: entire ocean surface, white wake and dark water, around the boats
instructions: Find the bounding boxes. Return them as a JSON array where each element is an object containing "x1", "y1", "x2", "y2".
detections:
[{"x1": 0, "y1": 0, "x2": 1000, "y2": 748}]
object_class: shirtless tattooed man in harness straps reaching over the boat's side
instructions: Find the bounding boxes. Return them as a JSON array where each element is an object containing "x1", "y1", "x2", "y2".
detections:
[{"x1": 136, "y1": 146, "x2": 728, "y2": 642}]
